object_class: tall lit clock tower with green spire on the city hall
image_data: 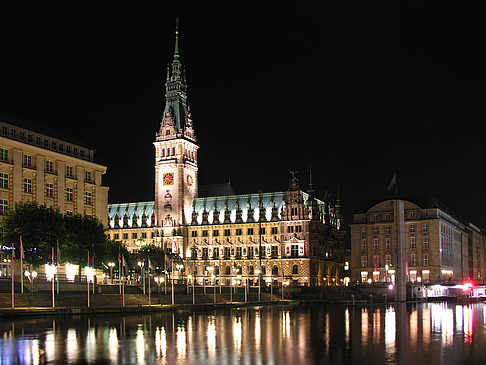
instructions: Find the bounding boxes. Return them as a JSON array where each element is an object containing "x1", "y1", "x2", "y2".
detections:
[{"x1": 154, "y1": 19, "x2": 199, "y2": 253}]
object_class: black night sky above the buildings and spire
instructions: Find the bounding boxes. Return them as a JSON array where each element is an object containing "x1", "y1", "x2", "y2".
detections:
[{"x1": 0, "y1": 1, "x2": 486, "y2": 227}]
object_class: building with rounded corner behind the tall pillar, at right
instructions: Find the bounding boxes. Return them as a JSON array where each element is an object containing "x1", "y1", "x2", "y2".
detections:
[{"x1": 351, "y1": 197, "x2": 486, "y2": 283}]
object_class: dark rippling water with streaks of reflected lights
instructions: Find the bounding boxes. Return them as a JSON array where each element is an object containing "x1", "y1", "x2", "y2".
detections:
[{"x1": 0, "y1": 303, "x2": 486, "y2": 365}]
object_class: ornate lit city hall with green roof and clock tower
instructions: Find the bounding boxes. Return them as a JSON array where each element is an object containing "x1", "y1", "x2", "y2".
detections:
[{"x1": 108, "y1": 27, "x2": 345, "y2": 286}]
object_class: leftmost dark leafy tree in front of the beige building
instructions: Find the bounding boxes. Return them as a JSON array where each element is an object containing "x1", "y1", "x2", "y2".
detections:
[{"x1": 0, "y1": 202, "x2": 66, "y2": 266}]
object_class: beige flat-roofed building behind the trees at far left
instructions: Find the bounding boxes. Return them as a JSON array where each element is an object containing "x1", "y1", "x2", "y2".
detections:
[{"x1": 0, "y1": 115, "x2": 108, "y2": 276}]
